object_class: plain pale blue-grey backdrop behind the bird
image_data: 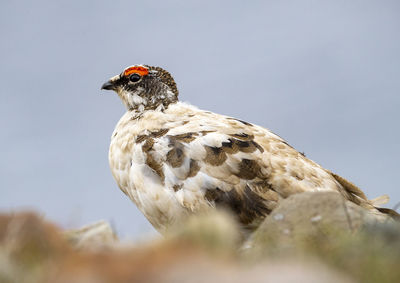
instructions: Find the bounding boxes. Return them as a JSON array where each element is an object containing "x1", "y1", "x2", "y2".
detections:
[{"x1": 0, "y1": 0, "x2": 400, "y2": 238}]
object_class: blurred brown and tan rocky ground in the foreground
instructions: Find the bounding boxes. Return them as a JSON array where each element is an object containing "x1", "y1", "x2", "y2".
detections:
[{"x1": 0, "y1": 193, "x2": 400, "y2": 283}]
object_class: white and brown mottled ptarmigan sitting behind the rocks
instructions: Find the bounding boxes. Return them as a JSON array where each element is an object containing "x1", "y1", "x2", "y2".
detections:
[{"x1": 101, "y1": 65, "x2": 398, "y2": 234}]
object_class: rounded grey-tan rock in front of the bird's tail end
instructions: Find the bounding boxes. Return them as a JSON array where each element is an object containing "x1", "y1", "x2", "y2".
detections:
[{"x1": 253, "y1": 192, "x2": 393, "y2": 245}]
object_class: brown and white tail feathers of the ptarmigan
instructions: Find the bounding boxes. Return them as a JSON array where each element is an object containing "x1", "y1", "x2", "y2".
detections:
[{"x1": 329, "y1": 172, "x2": 400, "y2": 222}]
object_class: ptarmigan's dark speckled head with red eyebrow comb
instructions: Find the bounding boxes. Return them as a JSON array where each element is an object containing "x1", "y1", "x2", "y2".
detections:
[{"x1": 101, "y1": 65, "x2": 178, "y2": 112}]
